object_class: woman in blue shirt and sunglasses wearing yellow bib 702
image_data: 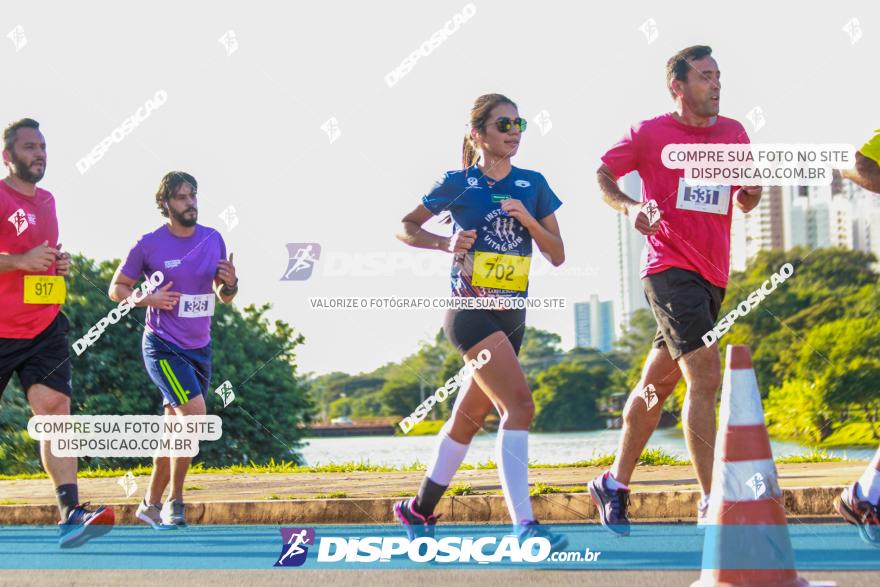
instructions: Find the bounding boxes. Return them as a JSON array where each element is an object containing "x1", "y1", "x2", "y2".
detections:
[{"x1": 394, "y1": 94, "x2": 568, "y2": 550}]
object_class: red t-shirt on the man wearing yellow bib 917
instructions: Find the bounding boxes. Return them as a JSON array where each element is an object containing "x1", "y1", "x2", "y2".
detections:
[{"x1": 0, "y1": 180, "x2": 61, "y2": 338}]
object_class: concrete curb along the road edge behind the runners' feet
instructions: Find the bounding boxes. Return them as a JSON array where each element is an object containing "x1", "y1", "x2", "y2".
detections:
[{"x1": 0, "y1": 486, "x2": 843, "y2": 526}]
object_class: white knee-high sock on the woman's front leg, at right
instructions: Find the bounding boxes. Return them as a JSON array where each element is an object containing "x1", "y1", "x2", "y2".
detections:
[{"x1": 495, "y1": 428, "x2": 535, "y2": 524}]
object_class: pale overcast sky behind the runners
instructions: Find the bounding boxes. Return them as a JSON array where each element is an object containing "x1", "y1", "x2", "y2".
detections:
[{"x1": 0, "y1": 0, "x2": 880, "y2": 373}]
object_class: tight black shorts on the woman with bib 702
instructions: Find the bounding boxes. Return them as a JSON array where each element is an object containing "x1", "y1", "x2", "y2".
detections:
[{"x1": 443, "y1": 309, "x2": 526, "y2": 354}]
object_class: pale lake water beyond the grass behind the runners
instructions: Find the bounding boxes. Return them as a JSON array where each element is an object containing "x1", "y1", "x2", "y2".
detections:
[{"x1": 302, "y1": 428, "x2": 874, "y2": 466}]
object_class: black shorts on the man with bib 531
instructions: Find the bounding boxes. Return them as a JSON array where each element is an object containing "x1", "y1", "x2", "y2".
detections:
[{"x1": 642, "y1": 267, "x2": 725, "y2": 360}]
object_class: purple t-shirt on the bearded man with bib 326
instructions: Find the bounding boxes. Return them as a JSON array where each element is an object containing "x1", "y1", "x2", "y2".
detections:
[{"x1": 122, "y1": 224, "x2": 226, "y2": 349}]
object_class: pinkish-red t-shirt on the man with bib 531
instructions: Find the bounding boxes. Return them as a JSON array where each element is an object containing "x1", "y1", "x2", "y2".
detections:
[{"x1": 602, "y1": 114, "x2": 749, "y2": 288}]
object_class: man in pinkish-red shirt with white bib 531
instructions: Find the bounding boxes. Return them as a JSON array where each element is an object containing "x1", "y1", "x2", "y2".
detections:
[{"x1": 590, "y1": 45, "x2": 761, "y2": 535}]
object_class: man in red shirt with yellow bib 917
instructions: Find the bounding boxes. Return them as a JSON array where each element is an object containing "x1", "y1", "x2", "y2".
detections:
[{"x1": 0, "y1": 118, "x2": 114, "y2": 548}]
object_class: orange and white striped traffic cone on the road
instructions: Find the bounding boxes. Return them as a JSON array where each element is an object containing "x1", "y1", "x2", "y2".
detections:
[{"x1": 692, "y1": 345, "x2": 835, "y2": 587}]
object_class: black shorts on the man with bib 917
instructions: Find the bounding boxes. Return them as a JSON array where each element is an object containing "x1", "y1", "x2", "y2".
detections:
[{"x1": 0, "y1": 312, "x2": 72, "y2": 397}]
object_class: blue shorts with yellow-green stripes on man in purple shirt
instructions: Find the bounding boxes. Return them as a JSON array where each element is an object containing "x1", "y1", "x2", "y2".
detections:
[{"x1": 142, "y1": 331, "x2": 211, "y2": 407}]
